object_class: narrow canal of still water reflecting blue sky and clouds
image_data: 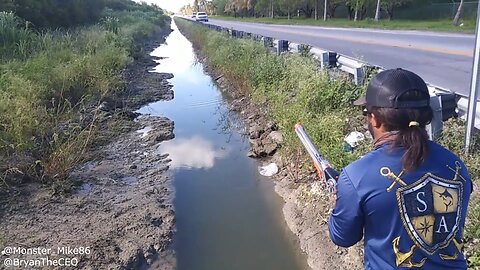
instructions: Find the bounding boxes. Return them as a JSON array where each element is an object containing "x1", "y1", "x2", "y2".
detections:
[{"x1": 140, "y1": 21, "x2": 308, "y2": 270}]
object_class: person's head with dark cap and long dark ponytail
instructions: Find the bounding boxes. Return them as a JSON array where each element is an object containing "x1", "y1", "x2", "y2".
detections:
[{"x1": 354, "y1": 69, "x2": 433, "y2": 170}]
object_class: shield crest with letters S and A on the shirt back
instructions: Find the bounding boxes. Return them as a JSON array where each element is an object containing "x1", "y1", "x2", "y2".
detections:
[{"x1": 396, "y1": 173, "x2": 463, "y2": 255}]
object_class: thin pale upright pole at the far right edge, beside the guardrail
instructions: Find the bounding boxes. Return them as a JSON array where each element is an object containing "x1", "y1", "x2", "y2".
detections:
[{"x1": 465, "y1": 0, "x2": 480, "y2": 154}]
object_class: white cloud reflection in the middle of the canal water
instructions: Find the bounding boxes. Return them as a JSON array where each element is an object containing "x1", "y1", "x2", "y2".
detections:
[{"x1": 159, "y1": 136, "x2": 228, "y2": 169}]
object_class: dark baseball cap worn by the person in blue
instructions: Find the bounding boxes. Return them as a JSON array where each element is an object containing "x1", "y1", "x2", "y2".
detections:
[{"x1": 353, "y1": 68, "x2": 430, "y2": 109}]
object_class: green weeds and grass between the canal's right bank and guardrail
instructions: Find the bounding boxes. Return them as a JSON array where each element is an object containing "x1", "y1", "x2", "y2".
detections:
[{"x1": 176, "y1": 19, "x2": 480, "y2": 269}]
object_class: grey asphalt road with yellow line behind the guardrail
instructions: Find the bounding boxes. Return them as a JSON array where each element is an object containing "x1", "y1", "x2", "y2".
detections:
[{"x1": 209, "y1": 20, "x2": 475, "y2": 95}]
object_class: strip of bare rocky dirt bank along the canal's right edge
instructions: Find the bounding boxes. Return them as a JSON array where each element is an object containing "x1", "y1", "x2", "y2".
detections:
[{"x1": 208, "y1": 71, "x2": 363, "y2": 270}]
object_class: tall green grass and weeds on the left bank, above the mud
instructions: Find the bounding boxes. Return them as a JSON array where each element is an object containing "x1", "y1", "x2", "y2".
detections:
[{"x1": 0, "y1": 11, "x2": 167, "y2": 186}]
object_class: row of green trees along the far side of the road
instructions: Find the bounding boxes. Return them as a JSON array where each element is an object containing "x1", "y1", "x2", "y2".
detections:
[{"x1": 180, "y1": 0, "x2": 472, "y2": 24}]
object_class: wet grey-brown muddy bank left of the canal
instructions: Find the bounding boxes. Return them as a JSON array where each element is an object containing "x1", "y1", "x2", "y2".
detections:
[{"x1": 0, "y1": 30, "x2": 175, "y2": 269}]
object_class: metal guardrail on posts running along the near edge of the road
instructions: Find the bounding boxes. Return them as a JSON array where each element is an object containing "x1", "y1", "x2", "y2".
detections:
[{"x1": 184, "y1": 18, "x2": 480, "y2": 132}]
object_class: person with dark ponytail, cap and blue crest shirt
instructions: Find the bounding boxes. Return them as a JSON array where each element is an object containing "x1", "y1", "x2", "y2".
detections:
[{"x1": 328, "y1": 69, "x2": 472, "y2": 270}]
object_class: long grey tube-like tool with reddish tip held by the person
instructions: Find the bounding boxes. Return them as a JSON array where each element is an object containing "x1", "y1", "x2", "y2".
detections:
[{"x1": 295, "y1": 123, "x2": 339, "y2": 193}]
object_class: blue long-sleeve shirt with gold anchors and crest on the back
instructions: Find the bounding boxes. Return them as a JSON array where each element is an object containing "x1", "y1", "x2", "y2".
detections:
[{"x1": 328, "y1": 142, "x2": 472, "y2": 270}]
